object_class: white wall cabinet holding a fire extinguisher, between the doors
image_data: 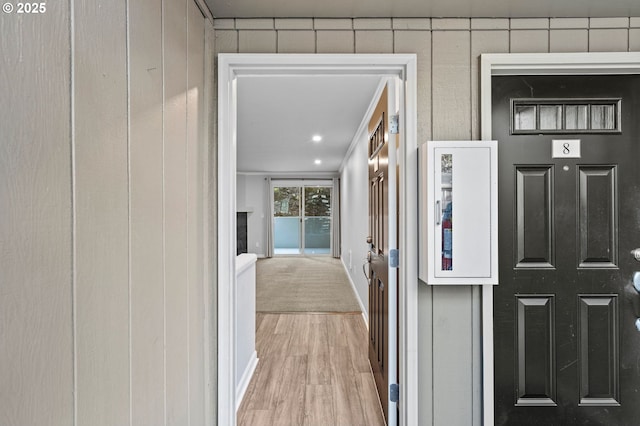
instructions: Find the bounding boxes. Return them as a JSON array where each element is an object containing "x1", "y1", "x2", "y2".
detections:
[{"x1": 419, "y1": 141, "x2": 498, "y2": 285}]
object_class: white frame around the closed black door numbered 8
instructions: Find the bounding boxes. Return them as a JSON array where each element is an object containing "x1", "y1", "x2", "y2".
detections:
[{"x1": 480, "y1": 52, "x2": 640, "y2": 426}]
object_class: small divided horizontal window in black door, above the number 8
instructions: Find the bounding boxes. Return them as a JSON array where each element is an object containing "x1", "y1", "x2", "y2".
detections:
[{"x1": 511, "y1": 98, "x2": 621, "y2": 135}]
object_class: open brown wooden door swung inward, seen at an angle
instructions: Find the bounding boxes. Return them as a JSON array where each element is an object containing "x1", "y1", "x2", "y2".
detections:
[{"x1": 368, "y1": 88, "x2": 395, "y2": 421}]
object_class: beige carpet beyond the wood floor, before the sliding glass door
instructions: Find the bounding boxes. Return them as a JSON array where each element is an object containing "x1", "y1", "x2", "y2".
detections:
[{"x1": 256, "y1": 256, "x2": 361, "y2": 312}]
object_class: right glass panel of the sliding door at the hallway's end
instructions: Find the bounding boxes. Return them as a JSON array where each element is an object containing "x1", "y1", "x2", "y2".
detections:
[{"x1": 304, "y1": 186, "x2": 331, "y2": 254}]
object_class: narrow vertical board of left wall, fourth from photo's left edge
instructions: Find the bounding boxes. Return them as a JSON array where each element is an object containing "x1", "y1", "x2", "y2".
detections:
[{"x1": 163, "y1": 0, "x2": 189, "y2": 426}]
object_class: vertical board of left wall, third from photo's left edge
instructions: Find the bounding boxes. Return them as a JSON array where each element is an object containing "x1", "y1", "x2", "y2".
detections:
[{"x1": 129, "y1": 0, "x2": 165, "y2": 426}]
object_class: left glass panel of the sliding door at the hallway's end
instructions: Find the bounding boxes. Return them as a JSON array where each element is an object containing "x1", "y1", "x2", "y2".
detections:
[{"x1": 273, "y1": 186, "x2": 302, "y2": 254}]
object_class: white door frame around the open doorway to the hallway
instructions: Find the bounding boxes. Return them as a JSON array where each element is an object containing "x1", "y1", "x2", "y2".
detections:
[{"x1": 217, "y1": 54, "x2": 418, "y2": 425}]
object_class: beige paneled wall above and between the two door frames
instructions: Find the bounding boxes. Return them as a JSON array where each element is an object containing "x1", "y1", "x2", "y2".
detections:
[{"x1": 214, "y1": 15, "x2": 640, "y2": 425}]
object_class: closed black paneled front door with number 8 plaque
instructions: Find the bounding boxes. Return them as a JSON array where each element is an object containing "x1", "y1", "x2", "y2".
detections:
[{"x1": 492, "y1": 76, "x2": 640, "y2": 426}]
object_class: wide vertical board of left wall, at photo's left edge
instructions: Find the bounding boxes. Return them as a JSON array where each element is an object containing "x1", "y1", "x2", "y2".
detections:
[{"x1": 0, "y1": 1, "x2": 74, "y2": 426}]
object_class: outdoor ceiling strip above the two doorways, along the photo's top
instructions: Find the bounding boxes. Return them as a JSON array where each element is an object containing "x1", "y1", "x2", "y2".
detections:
[{"x1": 206, "y1": 0, "x2": 640, "y2": 18}]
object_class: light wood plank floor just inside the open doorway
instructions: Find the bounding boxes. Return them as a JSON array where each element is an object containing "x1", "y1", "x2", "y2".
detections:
[{"x1": 238, "y1": 313, "x2": 385, "y2": 426}]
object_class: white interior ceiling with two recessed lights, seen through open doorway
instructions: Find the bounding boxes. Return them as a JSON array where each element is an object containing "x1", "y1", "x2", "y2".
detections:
[{"x1": 237, "y1": 75, "x2": 380, "y2": 175}]
